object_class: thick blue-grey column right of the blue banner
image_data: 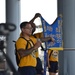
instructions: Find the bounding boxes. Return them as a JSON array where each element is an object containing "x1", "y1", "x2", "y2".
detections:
[{"x1": 58, "y1": 0, "x2": 75, "y2": 75}]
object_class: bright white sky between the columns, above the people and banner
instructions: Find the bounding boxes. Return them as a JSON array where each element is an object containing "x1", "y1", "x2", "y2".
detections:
[{"x1": 0, "y1": 0, "x2": 57, "y2": 24}]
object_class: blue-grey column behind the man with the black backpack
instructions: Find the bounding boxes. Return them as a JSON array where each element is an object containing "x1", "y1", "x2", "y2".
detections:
[{"x1": 6, "y1": 0, "x2": 20, "y2": 69}]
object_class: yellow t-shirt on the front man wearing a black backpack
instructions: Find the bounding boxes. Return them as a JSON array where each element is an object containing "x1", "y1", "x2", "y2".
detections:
[{"x1": 16, "y1": 36, "x2": 37, "y2": 67}]
